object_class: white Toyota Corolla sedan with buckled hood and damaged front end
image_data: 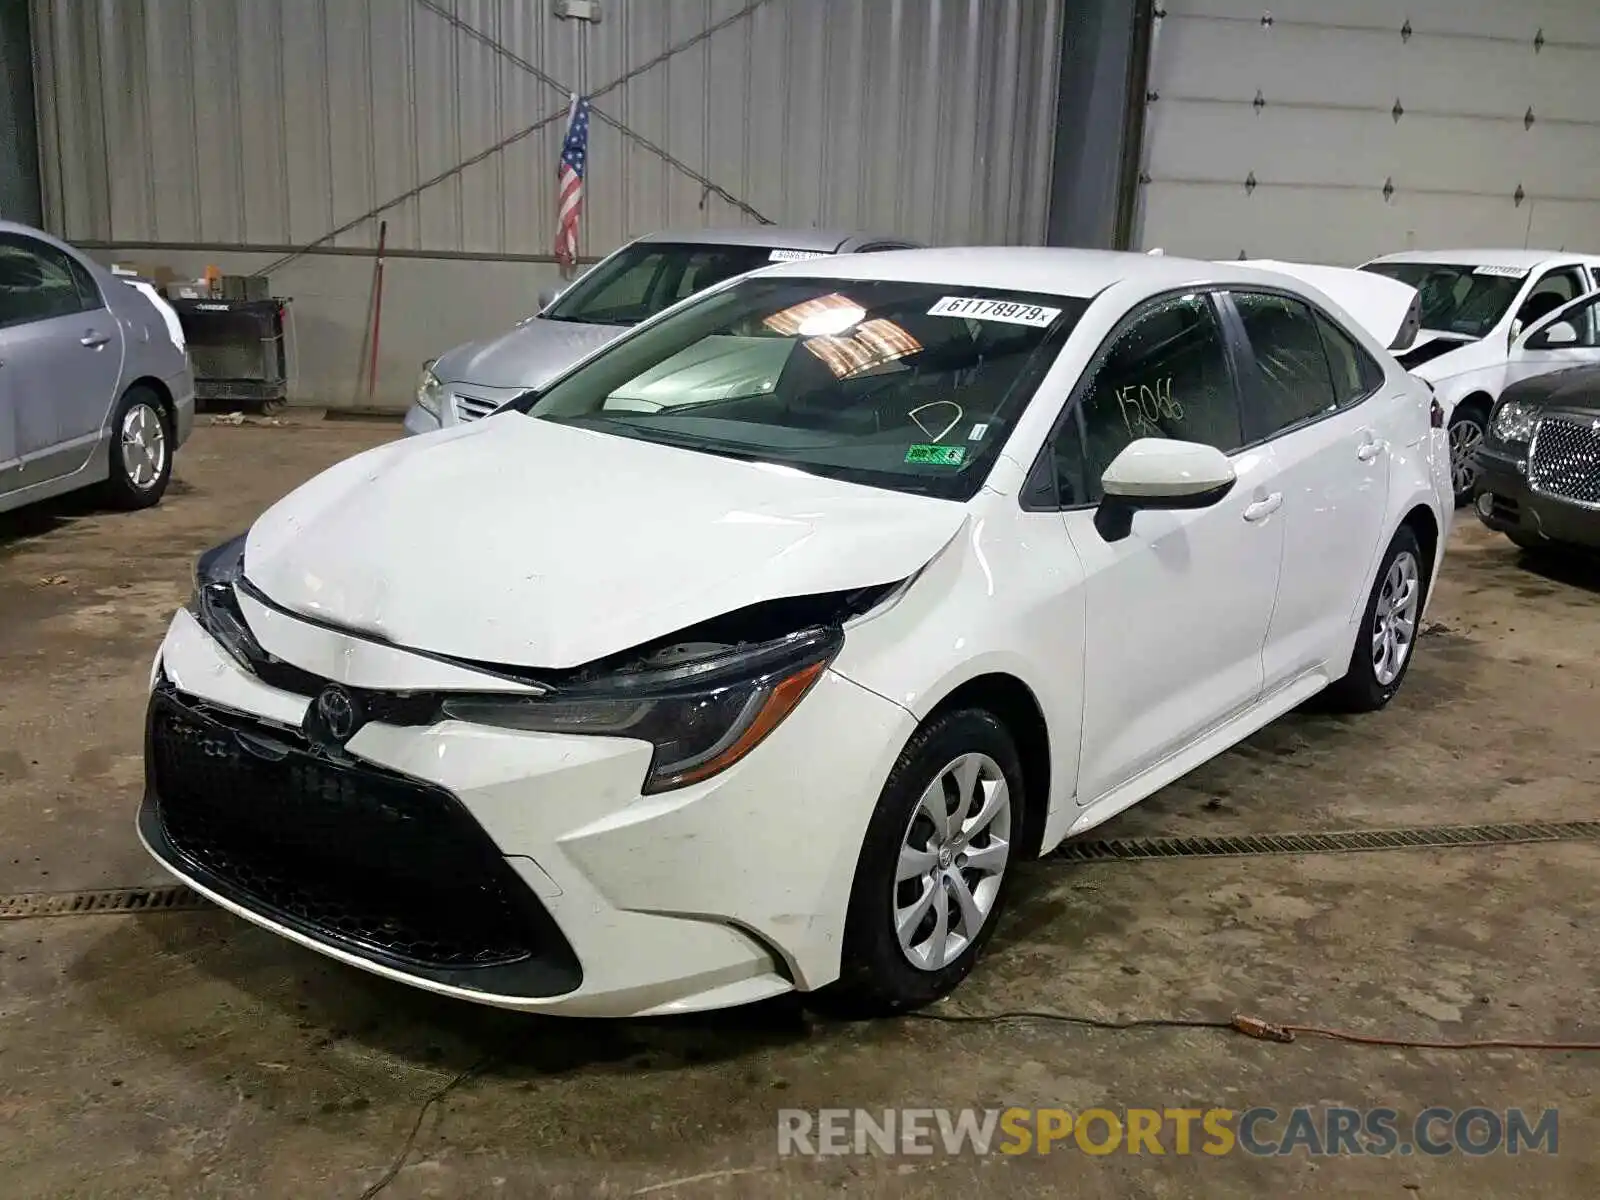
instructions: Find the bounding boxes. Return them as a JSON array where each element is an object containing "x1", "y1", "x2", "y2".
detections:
[{"x1": 139, "y1": 248, "x2": 1453, "y2": 1016}]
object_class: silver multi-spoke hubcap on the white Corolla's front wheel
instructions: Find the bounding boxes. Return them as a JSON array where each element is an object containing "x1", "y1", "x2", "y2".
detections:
[{"x1": 894, "y1": 754, "x2": 1011, "y2": 971}]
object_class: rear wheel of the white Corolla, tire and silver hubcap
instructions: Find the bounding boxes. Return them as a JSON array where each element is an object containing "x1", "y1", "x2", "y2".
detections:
[{"x1": 1328, "y1": 525, "x2": 1427, "y2": 712}]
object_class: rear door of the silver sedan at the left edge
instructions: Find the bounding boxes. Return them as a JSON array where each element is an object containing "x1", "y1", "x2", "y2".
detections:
[{"x1": 0, "y1": 234, "x2": 123, "y2": 486}]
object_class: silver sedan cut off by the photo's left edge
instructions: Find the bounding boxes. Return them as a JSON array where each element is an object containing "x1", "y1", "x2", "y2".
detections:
[{"x1": 0, "y1": 221, "x2": 195, "y2": 512}]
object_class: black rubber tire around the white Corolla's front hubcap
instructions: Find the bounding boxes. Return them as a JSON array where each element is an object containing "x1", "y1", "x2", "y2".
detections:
[{"x1": 816, "y1": 709, "x2": 1029, "y2": 1016}]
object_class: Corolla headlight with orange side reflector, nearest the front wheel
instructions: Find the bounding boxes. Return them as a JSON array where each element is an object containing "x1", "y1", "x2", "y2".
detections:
[{"x1": 443, "y1": 627, "x2": 843, "y2": 795}]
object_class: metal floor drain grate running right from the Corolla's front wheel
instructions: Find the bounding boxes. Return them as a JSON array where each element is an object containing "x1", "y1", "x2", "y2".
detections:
[{"x1": 1056, "y1": 821, "x2": 1600, "y2": 862}]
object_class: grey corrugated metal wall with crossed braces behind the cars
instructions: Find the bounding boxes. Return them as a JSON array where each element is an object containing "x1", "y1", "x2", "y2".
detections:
[{"x1": 34, "y1": 0, "x2": 1064, "y2": 256}]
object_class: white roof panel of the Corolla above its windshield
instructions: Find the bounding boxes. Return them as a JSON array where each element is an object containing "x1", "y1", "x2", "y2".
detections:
[{"x1": 748, "y1": 246, "x2": 1350, "y2": 299}]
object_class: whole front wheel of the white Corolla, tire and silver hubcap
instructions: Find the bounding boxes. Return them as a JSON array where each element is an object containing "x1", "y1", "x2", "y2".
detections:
[{"x1": 819, "y1": 709, "x2": 1026, "y2": 1014}]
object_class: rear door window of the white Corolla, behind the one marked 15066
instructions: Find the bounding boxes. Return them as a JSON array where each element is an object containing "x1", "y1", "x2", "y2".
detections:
[{"x1": 1234, "y1": 291, "x2": 1338, "y2": 438}]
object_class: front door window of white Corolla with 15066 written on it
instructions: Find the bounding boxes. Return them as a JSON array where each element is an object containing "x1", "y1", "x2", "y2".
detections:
[{"x1": 1054, "y1": 294, "x2": 1245, "y2": 506}]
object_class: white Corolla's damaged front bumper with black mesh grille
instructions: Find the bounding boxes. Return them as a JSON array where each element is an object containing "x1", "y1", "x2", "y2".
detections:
[{"x1": 139, "y1": 610, "x2": 914, "y2": 1016}]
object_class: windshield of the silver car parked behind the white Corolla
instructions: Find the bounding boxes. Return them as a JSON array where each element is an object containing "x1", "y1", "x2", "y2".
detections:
[{"x1": 539, "y1": 242, "x2": 802, "y2": 325}]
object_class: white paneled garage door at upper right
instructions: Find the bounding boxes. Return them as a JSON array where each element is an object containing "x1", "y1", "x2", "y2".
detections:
[{"x1": 1139, "y1": 0, "x2": 1600, "y2": 264}]
